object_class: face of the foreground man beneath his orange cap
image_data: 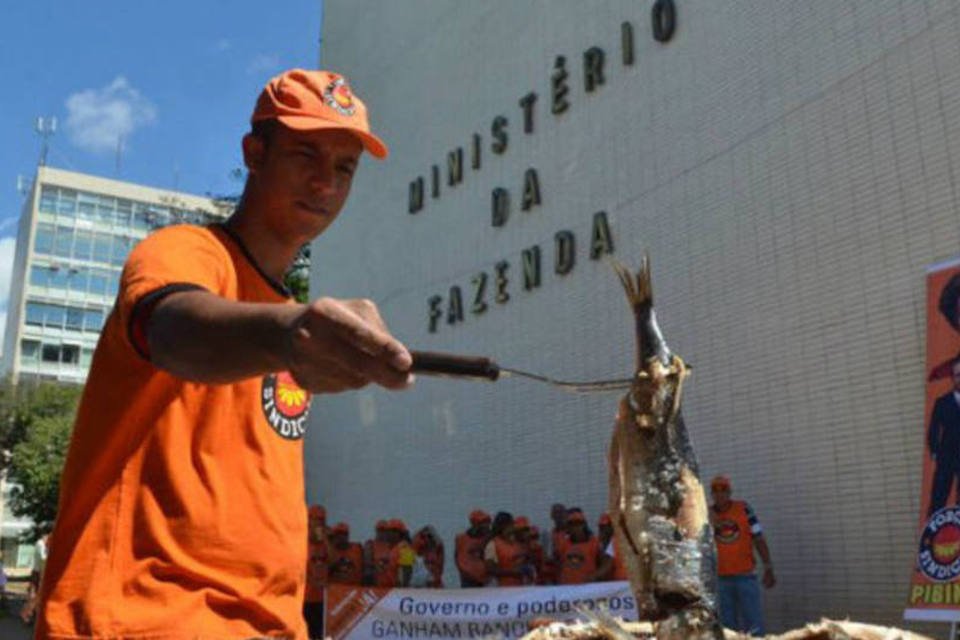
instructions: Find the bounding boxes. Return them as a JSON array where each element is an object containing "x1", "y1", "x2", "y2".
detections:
[{"x1": 244, "y1": 126, "x2": 363, "y2": 242}]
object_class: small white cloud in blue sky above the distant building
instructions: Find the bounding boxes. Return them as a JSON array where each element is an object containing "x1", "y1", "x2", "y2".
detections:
[{"x1": 67, "y1": 76, "x2": 157, "y2": 153}]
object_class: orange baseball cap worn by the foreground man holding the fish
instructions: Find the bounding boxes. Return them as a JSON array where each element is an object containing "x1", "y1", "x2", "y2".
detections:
[{"x1": 250, "y1": 69, "x2": 389, "y2": 159}]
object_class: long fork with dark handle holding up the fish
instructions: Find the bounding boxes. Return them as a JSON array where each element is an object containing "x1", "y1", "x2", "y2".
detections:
[{"x1": 411, "y1": 351, "x2": 633, "y2": 393}]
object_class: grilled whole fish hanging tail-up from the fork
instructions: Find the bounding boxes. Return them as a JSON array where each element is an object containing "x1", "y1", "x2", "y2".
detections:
[{"x1": 609, "y1": 257, "x2": 723, "y2": 640}]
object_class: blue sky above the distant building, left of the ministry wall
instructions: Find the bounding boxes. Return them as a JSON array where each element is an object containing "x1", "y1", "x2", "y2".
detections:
[{"x1": 0, "y1": 0, "x2": 322, "y2": 340}]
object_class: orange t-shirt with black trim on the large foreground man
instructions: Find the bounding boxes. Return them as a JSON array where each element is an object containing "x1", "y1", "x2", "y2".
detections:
[{"x1": 37, "y1": 225, "x2": 310, "y2": 640}]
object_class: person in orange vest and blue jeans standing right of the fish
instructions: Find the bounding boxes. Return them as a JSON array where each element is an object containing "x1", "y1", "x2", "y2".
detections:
[{"x1": 710, "y1": 476, "x2": 777, "y2": 636}]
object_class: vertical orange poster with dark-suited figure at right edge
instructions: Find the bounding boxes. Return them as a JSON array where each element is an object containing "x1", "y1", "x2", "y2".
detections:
[{"x1": 904, "y1": 259, "x2": 960, "y2": 622}]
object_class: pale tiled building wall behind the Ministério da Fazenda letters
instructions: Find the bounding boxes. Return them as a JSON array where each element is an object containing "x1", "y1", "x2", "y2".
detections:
[{"x1": 307, "y1": 0, "x2": 960, "y2": 629}]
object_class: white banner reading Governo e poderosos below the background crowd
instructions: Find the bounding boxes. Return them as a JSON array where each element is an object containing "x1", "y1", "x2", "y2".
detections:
[{"x1": 324, "y1": 582, "x2": 637, "y2": 640}]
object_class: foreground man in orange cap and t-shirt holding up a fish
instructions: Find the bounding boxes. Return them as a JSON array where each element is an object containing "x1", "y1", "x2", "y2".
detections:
[{"x1": 36, "y1": 69, "x2": 412, "y2": 640}]
